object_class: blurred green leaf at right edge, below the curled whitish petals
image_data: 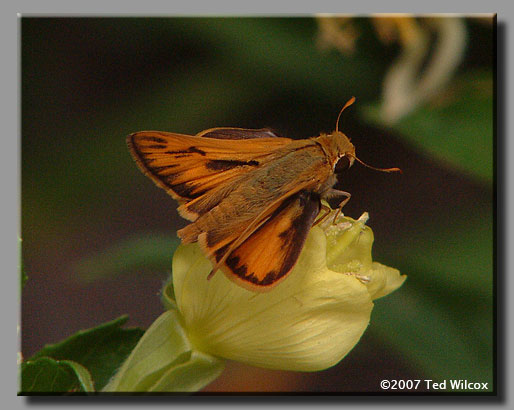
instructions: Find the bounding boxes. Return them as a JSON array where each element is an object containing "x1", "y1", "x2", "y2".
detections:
[{"x1": 363, "y1": 71, "x2": 494, "y2": 183}]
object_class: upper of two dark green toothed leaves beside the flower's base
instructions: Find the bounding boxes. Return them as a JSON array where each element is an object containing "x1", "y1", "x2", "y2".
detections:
[{"x1": 29, "y1": 316, "x2": 144, "y2": 390}]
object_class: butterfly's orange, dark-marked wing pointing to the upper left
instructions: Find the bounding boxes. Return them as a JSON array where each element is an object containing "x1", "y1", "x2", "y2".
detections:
[{"x1": 127, "y1": 128, "x2": 292, "y2": 221}]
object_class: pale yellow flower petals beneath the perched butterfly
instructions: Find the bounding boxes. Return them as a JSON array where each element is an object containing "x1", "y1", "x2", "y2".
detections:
[{"x1": 168, "y1": 214, "x2": 405, "y2": 371}]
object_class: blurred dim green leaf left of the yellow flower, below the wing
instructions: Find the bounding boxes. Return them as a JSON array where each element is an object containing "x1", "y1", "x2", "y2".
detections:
[{"x1": 75, "y1": 235, "x2": 180, "y2": 282}]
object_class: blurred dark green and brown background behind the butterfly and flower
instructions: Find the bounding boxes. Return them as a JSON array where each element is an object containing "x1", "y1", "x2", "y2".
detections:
[{"x1": 20, "y1": 16, "x2": 495, "y2": 392}]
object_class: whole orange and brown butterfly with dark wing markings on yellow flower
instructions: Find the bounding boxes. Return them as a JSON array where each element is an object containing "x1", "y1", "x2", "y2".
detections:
[{"x1": 127, "y1": 97, "x2": 399, "y2": 292}]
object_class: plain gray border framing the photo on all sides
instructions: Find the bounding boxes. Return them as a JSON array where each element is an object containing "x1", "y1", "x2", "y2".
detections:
[{"x1": 6, "y1": 0, "x2": 514, "y2": 408}]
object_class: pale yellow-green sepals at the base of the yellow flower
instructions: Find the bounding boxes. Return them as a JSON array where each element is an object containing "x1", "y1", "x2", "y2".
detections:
[{"x1": 103, "y1": 310, "x2": 224, "y2": 392}]
